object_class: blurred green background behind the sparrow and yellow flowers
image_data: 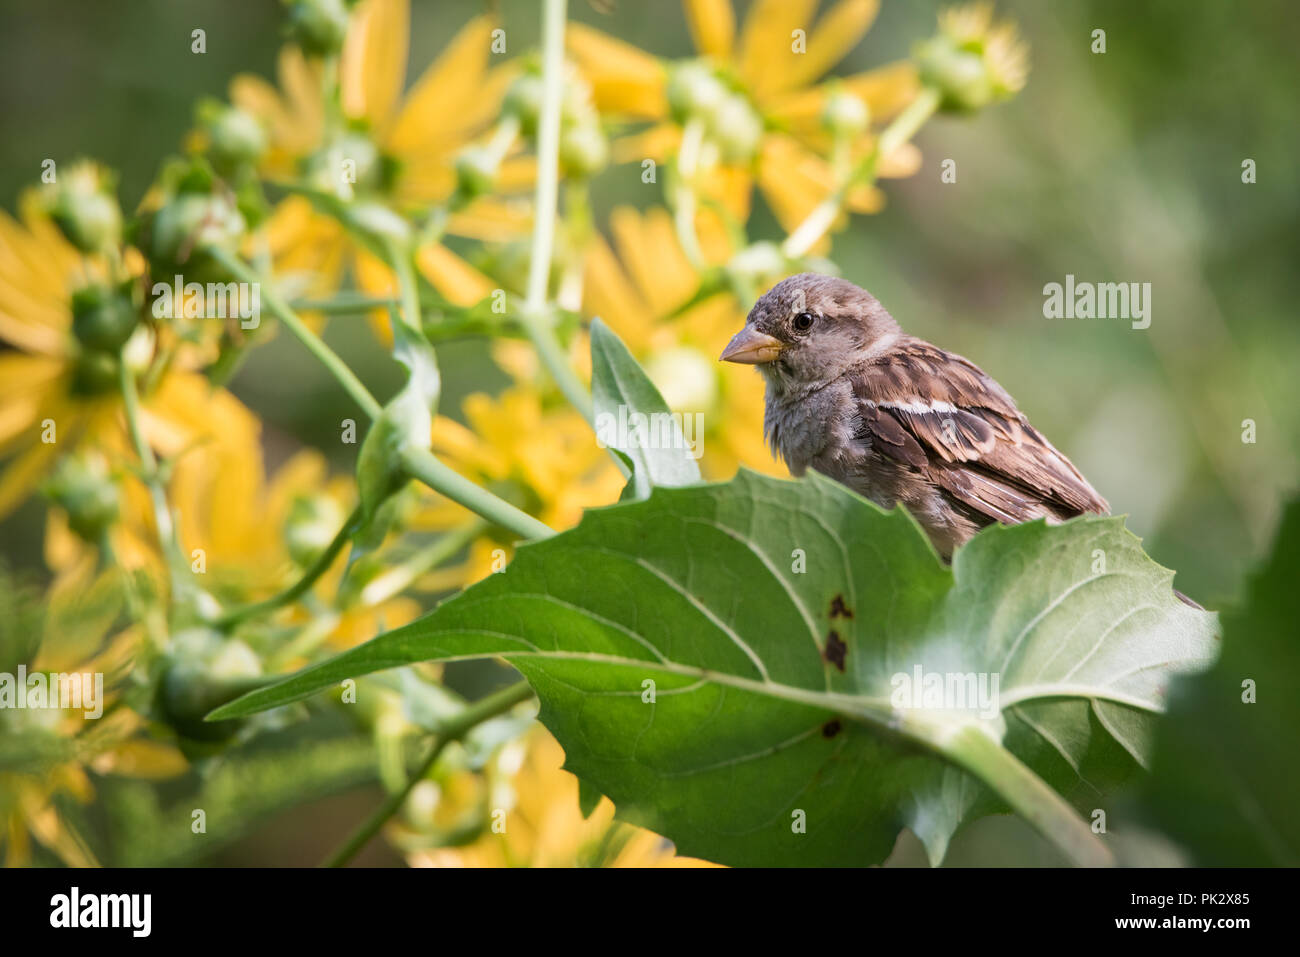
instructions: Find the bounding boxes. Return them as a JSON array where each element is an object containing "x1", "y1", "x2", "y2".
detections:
[{"x1": 0, "y1": 0, "x2": 1300, "y2": 863}]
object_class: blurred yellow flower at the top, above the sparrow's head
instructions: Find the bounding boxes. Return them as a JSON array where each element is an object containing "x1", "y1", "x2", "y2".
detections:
[{"x1": 568, "y1": 0, "x2": 920, "y2": 237}]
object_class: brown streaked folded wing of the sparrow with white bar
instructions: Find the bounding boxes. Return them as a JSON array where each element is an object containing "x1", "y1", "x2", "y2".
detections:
[{"x1": 852, "y1": 339, "x2": 1109, "y2": 523}]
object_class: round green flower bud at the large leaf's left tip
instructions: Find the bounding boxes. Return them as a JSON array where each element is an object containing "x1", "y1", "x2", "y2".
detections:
[{"x1": 159, "y1": 628, "x2": 261, "y2": 742}]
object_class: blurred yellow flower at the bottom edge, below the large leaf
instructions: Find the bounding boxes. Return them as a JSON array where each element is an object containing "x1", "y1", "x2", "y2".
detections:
[{"x1": 408, "y1": 728, "x2": 715, "y2": 867}]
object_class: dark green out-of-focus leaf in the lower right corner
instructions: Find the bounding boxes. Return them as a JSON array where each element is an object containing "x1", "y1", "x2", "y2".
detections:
[{"x1": 1145, "y1": 499, "x2": 1300, "y2": 867}]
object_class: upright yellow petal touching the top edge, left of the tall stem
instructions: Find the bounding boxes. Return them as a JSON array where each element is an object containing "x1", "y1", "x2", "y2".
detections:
[{"x1": 339, "y1": 0, "x2": 411, "y2": 139}]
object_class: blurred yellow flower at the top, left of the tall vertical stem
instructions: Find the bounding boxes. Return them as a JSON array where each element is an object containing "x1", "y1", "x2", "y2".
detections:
[{"x1": 230, "y1": 0, "x2": 534, "y2": 314}]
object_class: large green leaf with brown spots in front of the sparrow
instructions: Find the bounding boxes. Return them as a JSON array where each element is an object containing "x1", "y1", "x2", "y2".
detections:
[{"x1": 209, "y1": 472, "x2": 1216, "y2": 865}]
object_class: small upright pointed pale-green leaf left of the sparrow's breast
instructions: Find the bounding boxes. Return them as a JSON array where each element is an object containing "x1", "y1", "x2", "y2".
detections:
[{"x1": 592, "y1": 319, "x2": 699, "y2": 499}]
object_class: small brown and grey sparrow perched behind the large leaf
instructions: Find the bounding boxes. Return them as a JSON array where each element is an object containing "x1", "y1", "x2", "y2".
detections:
[{"x1": 722, "y1": 273, "x2": 1109, "y2": 560}]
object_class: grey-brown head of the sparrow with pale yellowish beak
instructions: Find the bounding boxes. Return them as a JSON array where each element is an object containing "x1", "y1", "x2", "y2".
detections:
[{"x1": 720, "y1": 273, "x2": 900, "y2": 387}]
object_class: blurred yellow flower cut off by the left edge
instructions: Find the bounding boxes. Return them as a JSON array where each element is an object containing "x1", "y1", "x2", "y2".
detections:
[{"x1": 0, "y1": 191, "x2": 254, "y2": 522}]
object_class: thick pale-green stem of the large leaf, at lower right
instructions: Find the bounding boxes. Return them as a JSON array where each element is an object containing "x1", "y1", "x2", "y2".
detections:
[{"x1": 920, "y1": 726, "x2": 1115, "y2": 867}]
